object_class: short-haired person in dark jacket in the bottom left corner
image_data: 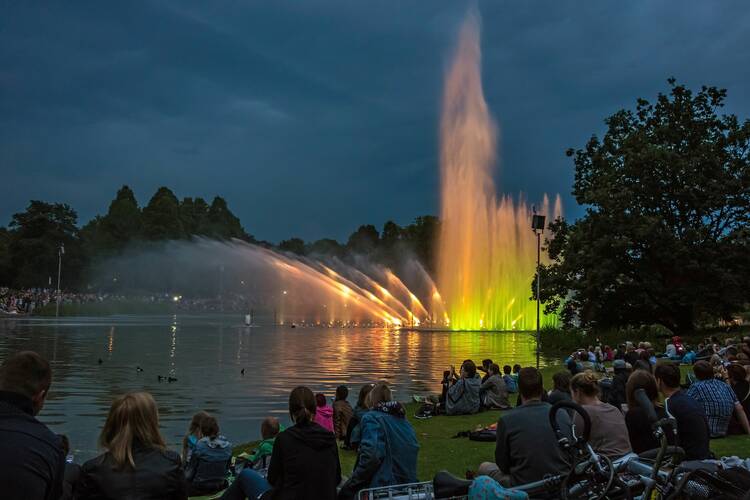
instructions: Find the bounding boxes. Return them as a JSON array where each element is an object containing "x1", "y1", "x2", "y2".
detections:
[{"x1": 0, "y1": 351, "x2": 65, "y2": 500}]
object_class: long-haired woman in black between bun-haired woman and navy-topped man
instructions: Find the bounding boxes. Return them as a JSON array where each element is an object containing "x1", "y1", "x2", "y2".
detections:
[{"x1": 625, "y1": 370, "x2": 675, "y2": 453}]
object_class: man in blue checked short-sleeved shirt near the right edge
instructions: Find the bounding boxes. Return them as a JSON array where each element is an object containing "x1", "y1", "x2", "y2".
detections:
[{"x1": 687, "y1": 361, "x2": 750, "y2": 438}]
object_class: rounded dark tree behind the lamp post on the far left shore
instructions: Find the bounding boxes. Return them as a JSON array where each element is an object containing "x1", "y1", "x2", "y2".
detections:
[{"x1": 10, "y1": 200, "x2": 85, "y2": 288}]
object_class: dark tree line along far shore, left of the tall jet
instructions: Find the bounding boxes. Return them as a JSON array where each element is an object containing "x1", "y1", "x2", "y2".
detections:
[{"x1": 0, "y1": 186, "x2": 438, "y2": 290}]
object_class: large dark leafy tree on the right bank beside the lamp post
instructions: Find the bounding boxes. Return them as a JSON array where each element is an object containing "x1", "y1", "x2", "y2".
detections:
[{"x1": 542, "y1": 79, "x2": 750, "y2": 333}]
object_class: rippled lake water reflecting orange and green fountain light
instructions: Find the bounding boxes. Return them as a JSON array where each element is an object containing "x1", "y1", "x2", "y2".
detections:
[{"x1": 0, "y1": 314, "x2": 545, "y2": 461}]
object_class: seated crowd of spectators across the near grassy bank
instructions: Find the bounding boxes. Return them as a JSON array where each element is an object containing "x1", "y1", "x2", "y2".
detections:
[{"x1": 0, "y1": 337, "x2": 750, "y2": 500}]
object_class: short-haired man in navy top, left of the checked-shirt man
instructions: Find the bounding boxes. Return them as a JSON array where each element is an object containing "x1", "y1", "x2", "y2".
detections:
[{"x1": 654, "y1": 363, "x2": 711, "y2": 460}]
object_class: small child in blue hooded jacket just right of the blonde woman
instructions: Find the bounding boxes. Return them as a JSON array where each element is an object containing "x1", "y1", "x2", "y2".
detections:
[{"x1": 185, "y1": 415, "x2": 232, "y2": 496}]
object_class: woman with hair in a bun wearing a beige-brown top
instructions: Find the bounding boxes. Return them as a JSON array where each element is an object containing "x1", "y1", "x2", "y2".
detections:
[{"x1": 570, "y1": 371, "x2": 631, "y2": 458}]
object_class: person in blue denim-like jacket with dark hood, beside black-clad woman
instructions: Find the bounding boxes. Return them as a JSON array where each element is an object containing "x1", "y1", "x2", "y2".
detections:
[{"x1": 338, "y1": 379, "x2": 420, "y2": 500}]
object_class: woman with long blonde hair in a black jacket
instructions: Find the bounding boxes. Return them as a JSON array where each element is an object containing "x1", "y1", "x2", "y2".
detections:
[{"x1": 76, "y1": 392, "x2": 187, "y2": 500}]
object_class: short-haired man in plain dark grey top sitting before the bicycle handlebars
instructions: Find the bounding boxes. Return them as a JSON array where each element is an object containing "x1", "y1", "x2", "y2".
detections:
[{"x1": 477, "y1": 368, "x2": 570, "y2": 487}]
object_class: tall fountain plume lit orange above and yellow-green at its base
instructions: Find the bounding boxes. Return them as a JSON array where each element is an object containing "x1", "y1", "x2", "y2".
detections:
[{"x1": 438, "y1": 9, "x2": 560, "y2": 330}]
